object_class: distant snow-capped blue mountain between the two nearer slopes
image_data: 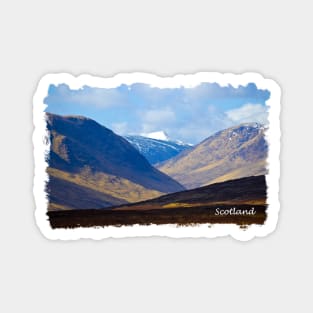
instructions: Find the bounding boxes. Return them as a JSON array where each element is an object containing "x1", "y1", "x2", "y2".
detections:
[{"x1": 125, "y1": 131, "x2": 192, "y2": 165}]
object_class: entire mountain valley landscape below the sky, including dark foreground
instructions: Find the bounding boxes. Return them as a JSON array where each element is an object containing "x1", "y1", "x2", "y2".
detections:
[{"x1": 46, "y1": 113, "x2": 267, "y2": 228}]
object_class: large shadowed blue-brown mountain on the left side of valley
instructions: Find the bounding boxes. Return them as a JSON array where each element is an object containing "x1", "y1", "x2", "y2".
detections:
[{"x1": 47, "y1": 113, "x2": 184, "y2": 210}]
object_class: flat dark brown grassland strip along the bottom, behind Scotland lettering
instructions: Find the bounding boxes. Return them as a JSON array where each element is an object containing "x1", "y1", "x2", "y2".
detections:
[{"x1": 48, "y1": 205, "x2": 266, "y2": 228}]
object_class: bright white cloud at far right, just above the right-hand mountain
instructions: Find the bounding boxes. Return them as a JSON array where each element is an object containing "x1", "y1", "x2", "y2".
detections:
[{"x1": 226, "y1": 104, "x2": 268, "y2": 124}]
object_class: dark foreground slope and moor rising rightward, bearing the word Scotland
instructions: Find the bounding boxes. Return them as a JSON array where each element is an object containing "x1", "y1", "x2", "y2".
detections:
[{"x1": 48, "y1": 175, "x2": 267, "y2": 228}]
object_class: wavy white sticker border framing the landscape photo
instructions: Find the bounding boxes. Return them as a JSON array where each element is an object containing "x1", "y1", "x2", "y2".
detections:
[{"x1": 33, "y1": 72, "x2": 281, "y2": 241}]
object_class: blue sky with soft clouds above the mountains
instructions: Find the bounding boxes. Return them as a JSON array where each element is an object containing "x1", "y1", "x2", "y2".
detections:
[{"x1": 44, "y1": 83, "x2": 270, "y2": 144}]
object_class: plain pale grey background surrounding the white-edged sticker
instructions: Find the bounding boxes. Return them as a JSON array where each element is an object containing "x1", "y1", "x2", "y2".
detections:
[{"x1": 0, "y1": 0, "x2": 313, "y2": 312}]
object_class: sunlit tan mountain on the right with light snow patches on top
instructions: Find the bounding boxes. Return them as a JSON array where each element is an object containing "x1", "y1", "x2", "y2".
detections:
[{"x1": 157, "y1": 123, "x2": 268, "y2": 189}]
